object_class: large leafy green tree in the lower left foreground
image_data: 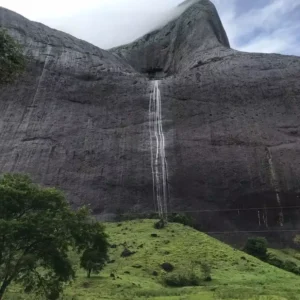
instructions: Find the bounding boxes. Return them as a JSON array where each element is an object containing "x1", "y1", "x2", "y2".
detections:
[{"x1": 0, "y1": 174, "x2": 107, "y2": 300}]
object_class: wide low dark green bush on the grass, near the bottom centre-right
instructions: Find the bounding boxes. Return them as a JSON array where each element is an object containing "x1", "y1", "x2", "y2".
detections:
[{"x1": 164, "y1": 271, "x2": 201, "y2": 287}]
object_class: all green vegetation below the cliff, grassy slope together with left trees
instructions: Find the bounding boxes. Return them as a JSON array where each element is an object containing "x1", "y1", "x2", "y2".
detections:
[{"x1": 0, "y1": 175, "x2": 300, "y2": 300}]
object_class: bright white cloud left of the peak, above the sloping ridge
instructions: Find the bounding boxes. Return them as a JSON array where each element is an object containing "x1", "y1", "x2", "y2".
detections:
[{"x1": 1, "y1": 0, "x2": 182, "y2": 49}]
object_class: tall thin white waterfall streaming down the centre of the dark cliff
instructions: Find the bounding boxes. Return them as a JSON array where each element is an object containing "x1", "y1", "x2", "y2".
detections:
[{"x1": 149, "y1": 80, "x2": 168, "y2": 220}]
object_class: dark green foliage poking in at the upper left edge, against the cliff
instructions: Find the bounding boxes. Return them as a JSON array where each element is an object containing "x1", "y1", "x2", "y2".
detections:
[{"x1": 0, "y1": 28, "x2": 25, "y2": 84}]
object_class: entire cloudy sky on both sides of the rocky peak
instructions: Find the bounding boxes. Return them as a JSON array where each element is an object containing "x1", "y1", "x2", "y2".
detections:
[{"x1": 0, "y1": 0, "x2": 300, "y2": 56}]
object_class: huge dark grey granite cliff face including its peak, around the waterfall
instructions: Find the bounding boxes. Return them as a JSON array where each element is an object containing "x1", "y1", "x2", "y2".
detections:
[{"x1": 0, "y1": 0, "x2": 300, "y2": 237}]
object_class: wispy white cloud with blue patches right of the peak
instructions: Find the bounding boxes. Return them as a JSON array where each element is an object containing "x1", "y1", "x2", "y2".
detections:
[{"x1": 213, "y1": 0, "x2": 300, "y2": 55}]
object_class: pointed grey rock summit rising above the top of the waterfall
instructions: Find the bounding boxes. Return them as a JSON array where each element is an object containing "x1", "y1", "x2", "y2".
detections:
[{"x1": 112, "y1": 0, "x2": 230, "y2": 75}]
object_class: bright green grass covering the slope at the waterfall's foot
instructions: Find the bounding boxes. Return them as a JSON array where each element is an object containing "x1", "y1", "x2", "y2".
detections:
[{"x1": 5, "y1": 220, "x2": 300, "y2": 300}]
